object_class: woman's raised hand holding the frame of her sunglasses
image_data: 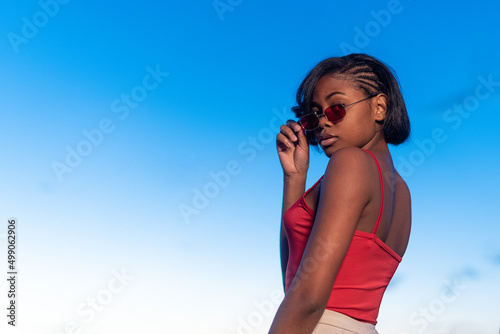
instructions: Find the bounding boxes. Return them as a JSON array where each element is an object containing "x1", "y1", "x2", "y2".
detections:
[{"x1": 276, "y1": 120, "x2": 309, "y2": 177}]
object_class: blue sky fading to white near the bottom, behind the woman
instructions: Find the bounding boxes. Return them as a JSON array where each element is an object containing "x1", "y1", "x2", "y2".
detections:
[{"x1": 0, "y1": 0, "x2": 500, "y2": 334}]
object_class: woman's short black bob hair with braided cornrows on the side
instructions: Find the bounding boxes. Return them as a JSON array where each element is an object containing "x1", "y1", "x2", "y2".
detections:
[{"x1": 292, "y1": 53, "x2": 410, "y2": 148}]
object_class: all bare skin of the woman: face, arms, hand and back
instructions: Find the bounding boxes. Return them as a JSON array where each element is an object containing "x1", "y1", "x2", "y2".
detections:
[{"x1": 269, "y1": 75, "x2": 411, "y2": 334}]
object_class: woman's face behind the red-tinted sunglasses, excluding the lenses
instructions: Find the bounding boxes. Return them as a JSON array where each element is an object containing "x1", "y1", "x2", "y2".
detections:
[{"x1": 311, "y1": 75, "x2": 385, "y2": 157}]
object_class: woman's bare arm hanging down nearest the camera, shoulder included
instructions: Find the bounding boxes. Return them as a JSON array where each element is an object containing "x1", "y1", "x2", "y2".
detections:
[{"x1": 270, "y1": 148, "x2": 378, "y2": 334}]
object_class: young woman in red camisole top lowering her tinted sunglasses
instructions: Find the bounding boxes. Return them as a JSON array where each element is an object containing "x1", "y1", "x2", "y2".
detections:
[{"x1": 270, "y1": 54, "x2": 411, "y2": 334}]
